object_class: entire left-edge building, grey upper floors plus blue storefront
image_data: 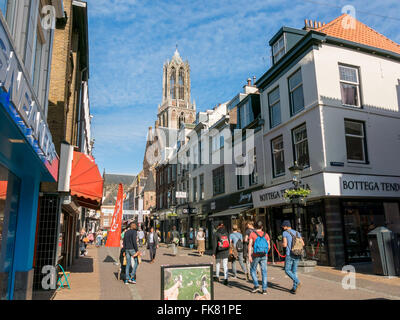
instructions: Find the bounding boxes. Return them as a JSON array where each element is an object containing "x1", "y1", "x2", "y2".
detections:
[{"x1": 0, "y1": 0, "x2": 62, "y2": 300}]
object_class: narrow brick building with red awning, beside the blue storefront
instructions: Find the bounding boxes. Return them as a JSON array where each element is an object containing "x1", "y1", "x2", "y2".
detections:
[{"x1": 33, "y1": 0, "x2": 103, "y2": 294}]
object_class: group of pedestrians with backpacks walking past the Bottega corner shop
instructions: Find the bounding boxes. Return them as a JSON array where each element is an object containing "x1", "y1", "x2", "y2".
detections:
[{"x1": 212, "y1": 220, "x2": 304, "y2": 294}]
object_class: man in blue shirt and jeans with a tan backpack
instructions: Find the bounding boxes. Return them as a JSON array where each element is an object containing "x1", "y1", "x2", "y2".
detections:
[{"x1": 282, "y1": 220, "x2": 304, "y2": 294}]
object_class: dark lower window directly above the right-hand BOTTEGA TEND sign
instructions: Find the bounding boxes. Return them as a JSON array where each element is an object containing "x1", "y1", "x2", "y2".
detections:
[{"x1": 344, "y1": 120, "x2": 367, "y2": 163}]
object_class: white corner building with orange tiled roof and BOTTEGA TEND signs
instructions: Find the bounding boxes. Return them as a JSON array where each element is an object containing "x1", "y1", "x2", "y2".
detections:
[{"x1": 252, "y1": 14, "x2": 400, "y2": 267}]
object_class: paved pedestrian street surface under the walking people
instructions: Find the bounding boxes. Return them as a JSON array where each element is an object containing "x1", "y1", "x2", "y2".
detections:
[{"x1": 54, "y1": 245, "x2": 400, "y2": 300}]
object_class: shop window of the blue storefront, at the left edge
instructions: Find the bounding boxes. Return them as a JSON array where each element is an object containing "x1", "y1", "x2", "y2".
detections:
[{"x1": 0, "y1": 165, "x2": 21, "y2": 300}]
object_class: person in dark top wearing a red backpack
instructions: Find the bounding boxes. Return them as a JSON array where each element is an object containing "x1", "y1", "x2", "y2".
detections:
[{"x1": 213, "y1": 222, "x2": 230, "y2": 285}]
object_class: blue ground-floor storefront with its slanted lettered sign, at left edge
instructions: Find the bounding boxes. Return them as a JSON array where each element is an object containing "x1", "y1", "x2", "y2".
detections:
[{"x1": 0, "y1": 17, "x2": 58, "y2": 300}]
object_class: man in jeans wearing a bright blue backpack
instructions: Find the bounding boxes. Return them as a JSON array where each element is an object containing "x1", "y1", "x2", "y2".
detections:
[{"x1": 248, "y1": 221, "x2": 270, "y2": 294}]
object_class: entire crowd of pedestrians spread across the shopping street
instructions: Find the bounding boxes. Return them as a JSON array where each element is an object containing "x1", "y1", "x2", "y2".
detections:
[{"x1": 90, "y1": 220, "x2": 304, "y2": 294}]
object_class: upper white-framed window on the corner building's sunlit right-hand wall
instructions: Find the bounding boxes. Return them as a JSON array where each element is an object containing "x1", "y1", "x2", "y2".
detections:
[{"x1": 339, "y1": 65, "x2": 361, "y2": 107}]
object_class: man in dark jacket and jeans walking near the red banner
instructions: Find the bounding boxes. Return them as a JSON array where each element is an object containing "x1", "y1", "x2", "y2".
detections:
[{"x1": 123, "y1": 222, "x2": 139, "y2": 284}]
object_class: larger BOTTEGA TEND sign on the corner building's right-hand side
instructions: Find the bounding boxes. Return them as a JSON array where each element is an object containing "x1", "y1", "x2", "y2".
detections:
[{"x1": 324, "y1": 173, "x2": 400, "y2": 197}]
